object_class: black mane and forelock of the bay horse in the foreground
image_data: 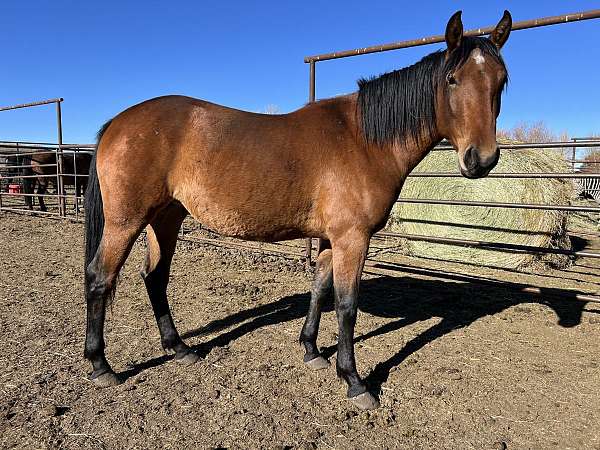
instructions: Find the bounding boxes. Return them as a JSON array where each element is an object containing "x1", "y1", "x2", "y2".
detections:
[{"x1": 358, "y1": 37, "x2": 504, "y2": 145}]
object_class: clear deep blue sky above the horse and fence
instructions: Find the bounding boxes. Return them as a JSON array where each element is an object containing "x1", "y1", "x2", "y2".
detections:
[{"x1": 0, "y1": 0, "x2": 600, "y2": 142}]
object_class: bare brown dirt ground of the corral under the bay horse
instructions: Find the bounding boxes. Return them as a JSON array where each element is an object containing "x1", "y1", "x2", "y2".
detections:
[{"x1": 0, "y1": 214, "x2": 600, "y2": 449}]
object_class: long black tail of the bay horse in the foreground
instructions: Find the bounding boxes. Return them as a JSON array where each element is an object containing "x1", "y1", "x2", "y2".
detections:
[{"x1": 84, "y1": 120, "x2": 111, "y2": 282}]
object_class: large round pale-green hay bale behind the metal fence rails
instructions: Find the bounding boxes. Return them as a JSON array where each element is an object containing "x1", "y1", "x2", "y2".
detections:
[{"x1": 388, "y1": 144, "x2": 573, "y2": 269}]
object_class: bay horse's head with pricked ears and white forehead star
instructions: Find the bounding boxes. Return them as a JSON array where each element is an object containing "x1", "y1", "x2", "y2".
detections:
[{"x1": 436, "y1": 11, "x2": 512, "y2": 178}]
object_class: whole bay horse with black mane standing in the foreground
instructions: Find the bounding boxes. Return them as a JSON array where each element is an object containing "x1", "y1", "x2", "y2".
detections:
[{"x1": 84, "y1": 11, "x2": 512, "y2": 409}]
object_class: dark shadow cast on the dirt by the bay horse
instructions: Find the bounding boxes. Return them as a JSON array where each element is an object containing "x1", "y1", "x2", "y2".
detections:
[{"x1": 121, "y1": 270, "x2": 600, "y2": 391}]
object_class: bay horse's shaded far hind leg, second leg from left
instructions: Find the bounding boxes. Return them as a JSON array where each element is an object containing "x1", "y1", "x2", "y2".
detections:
[{"x1": 142, "y1": 203, "x2": 199, "y2": 365}]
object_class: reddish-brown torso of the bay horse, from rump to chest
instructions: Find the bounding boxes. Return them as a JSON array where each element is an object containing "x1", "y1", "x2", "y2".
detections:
[{"x1": 97, "y1": 95, "x2": 408, "y2": 241}]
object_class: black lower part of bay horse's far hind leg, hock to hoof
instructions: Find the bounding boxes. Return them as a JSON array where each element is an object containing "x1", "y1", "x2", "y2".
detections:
[{"x1": 142, "y1": 260, "x2": 191, "y2": 359}]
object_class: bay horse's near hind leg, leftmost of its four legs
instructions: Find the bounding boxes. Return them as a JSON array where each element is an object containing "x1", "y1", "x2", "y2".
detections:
[{"x1": 84, "y1": 223, "x2": 143, "y2": 387}]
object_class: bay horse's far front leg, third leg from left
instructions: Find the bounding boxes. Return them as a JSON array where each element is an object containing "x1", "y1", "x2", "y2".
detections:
[{"x1": 300, "y1": 241, "x2": 333, "y2": 370}]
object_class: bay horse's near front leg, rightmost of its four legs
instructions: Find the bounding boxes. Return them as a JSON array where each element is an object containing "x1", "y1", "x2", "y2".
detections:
[{"x1": 332, "y1": 231, "x2": 379, "y2": 409}]
